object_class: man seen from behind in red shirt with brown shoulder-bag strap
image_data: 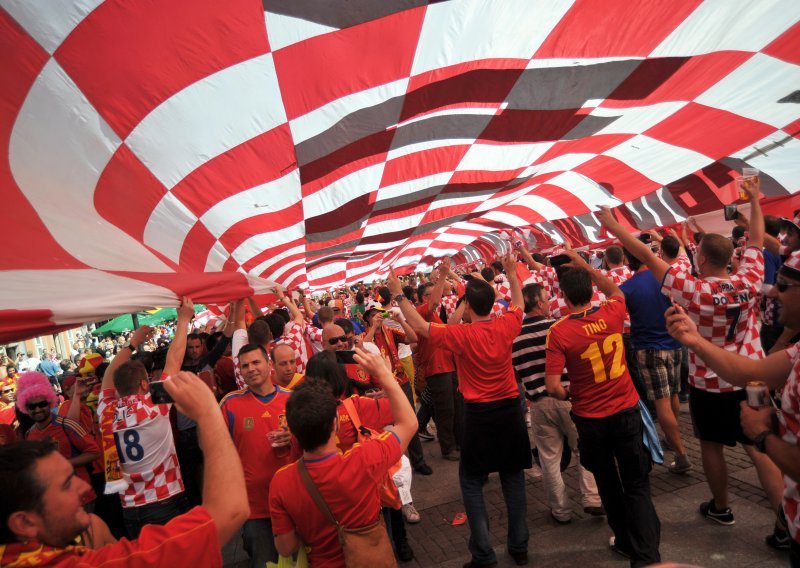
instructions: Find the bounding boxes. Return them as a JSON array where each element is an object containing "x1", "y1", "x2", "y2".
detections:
[{"x1": 270, "y1": 348, "x2": 417, "y2": 568}]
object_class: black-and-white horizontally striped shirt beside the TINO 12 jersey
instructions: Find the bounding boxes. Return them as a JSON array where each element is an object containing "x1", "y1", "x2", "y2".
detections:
[{"x1": 511, "y1": 316, "x2": 569, "y2": 400}]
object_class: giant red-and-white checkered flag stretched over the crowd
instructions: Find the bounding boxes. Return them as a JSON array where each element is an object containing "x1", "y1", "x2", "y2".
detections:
[{"x1": 0, "y1": 0, "x2": 800, "y2": 342}]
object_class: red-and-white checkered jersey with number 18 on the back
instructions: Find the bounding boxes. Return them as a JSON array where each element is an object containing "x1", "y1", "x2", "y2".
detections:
[{"x1": 97, "y1": 389, "x2": 183, "y2": 507}]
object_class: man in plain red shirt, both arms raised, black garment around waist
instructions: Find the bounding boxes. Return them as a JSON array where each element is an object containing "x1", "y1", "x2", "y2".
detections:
[{"x1": 389, "y1": 253, "x2": 532, "y2": 568}]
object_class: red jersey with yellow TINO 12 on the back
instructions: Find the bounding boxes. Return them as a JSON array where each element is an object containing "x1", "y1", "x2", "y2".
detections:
[{"x1": 545, "y1": 296, "x2": 639, "y2": 418}]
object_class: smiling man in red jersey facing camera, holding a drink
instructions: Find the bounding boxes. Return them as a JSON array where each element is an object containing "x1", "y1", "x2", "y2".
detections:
[{"x1": 220, "y1": 343, "x2": 300, "y2": 568}]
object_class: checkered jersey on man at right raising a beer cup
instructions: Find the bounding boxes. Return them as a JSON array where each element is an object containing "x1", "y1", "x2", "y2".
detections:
[{"x1": 662, "y1": 247, "x2": 764, "y2": 392}]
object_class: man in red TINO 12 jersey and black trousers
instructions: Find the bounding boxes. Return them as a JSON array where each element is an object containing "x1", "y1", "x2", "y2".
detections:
[{"x1": 545, "y1": 251, "x2": 661, "y2": 567}]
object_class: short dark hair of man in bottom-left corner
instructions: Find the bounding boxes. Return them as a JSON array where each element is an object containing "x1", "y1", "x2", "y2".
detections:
[{"x1": 0, "y1": 438, "x2": 58, "y2": 544}]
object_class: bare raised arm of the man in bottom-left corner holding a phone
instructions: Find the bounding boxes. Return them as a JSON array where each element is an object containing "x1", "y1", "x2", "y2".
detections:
[{"x1": 164, "y1": 371, "x2": 250, "y2": 545}]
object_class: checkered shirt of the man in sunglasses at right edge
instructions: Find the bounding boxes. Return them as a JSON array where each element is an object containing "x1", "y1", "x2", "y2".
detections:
[{"x1": 778, "y1": 343, "x2": 800, "y2": 543}]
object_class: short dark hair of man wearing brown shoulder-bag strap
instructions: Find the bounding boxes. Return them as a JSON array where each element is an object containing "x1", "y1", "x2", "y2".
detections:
[{"x1": 286, "y1": 379, "x2": 338, "y2": 452}]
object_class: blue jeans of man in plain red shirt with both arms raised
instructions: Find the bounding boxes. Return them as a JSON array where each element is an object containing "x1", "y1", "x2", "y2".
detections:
[{"x1": 458, "y1": 464, "x2": 528, "y2": 564}]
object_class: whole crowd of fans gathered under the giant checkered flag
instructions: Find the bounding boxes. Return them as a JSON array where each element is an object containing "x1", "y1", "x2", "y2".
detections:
[{"x1": 0, "y1": 176, "x2": 800, "y2": 568}]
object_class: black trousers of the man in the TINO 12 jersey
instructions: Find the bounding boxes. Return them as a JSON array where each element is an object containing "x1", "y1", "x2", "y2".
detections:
[{"x1": 573, "y1": 407, "x2": 661, "y2": 567}]
